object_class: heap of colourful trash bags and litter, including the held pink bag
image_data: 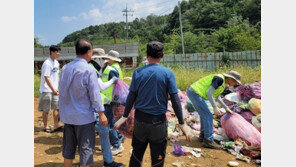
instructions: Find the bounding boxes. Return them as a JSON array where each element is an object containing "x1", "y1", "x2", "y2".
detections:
[{"x1": 113, "y1": 80, "x2": 261, "y2": 166}]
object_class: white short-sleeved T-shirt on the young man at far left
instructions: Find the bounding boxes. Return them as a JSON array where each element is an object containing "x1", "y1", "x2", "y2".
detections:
[{"x1": 39, "y1": 57, "x2": 60, "y2": 93}]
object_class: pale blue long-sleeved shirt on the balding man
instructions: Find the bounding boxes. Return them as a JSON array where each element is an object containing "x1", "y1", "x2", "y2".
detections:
[{"x1": 59, "y1": 57, "x2": 105, "y2": 125}]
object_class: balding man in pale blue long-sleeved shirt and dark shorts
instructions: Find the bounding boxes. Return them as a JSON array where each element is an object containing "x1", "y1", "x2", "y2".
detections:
[{"x1": 59, "y1": 39, "x2": 108, "y2": 167}]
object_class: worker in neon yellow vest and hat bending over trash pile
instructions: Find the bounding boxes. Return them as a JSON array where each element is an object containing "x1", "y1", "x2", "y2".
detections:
[{"x1": 187, "y1": 71, "x2": 241, "y2": 149}]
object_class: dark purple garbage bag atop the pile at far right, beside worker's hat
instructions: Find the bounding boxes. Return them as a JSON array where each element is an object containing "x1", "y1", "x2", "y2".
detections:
[{"x1": 236, "y1": 82, "x2": 261, "y2": 101}]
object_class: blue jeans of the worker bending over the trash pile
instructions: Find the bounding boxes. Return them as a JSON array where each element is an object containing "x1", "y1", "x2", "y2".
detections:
[{"x1": 187, "y1": 89, "x2": 213, "y2": 141}]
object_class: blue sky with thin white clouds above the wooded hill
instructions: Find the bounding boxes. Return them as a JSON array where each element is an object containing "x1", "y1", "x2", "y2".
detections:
[{"x1": 34, "y1": 0, "x2": 178, "y2": 46}]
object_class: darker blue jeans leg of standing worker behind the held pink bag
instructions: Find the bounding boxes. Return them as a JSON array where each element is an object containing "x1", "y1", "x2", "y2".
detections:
[{"x1": 104, "y1": 105, "x2": 121, "y2": 148}]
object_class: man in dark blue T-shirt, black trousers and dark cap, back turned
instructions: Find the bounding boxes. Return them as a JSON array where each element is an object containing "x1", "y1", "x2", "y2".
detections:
[{"x1": 114, "y1": 41, "x2": 192, "y2": 167}]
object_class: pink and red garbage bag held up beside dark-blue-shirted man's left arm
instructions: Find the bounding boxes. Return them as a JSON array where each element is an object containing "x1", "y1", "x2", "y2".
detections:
[{"x1": 112, "y1": 79, "x2": 135, "y2": 138}]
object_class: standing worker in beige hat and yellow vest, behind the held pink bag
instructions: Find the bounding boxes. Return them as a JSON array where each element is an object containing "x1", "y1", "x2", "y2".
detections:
[{"x1": 102, "y1": 50, "x2": 124, "y2": 155}]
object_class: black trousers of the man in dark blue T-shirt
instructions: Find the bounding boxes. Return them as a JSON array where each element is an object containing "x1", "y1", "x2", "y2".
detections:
[{"x1": 129, "y1": 119, "x2": 167, "y2": 167}]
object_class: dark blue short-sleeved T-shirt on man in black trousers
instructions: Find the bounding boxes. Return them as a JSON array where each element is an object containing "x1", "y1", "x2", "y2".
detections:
[{"x1": 129, "y1": 64, "x2": 178, "y2": 115}]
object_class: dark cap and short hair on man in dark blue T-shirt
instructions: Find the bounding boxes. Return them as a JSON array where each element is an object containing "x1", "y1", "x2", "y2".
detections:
[{"x1": 146, "y1": 41, "x2": 163, "y2": 59}]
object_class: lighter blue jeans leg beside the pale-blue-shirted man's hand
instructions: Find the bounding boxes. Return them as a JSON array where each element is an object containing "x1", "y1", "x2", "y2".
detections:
[{"x1": 95, "y1": 114, "x2": 113, "y2": 163}]
